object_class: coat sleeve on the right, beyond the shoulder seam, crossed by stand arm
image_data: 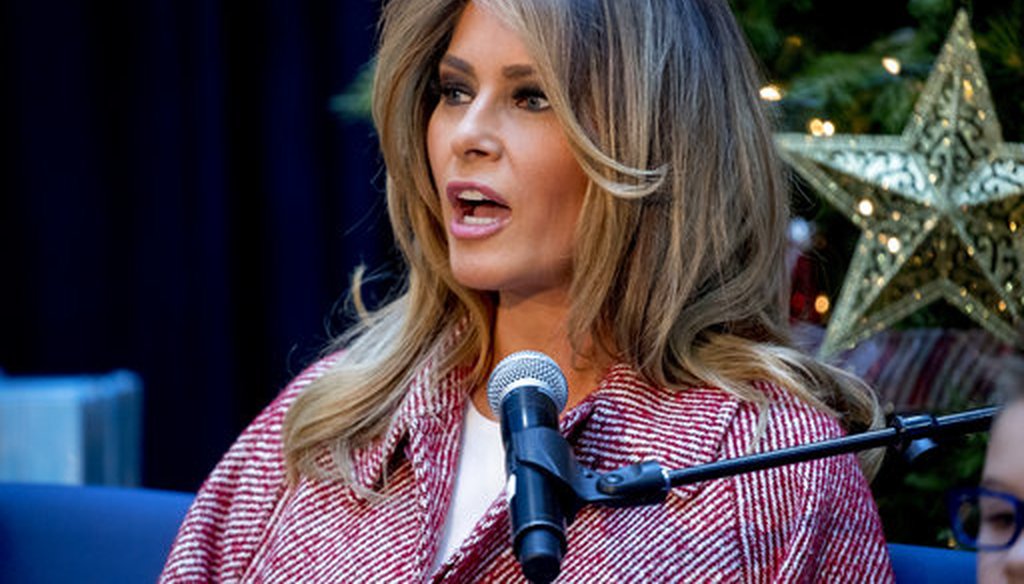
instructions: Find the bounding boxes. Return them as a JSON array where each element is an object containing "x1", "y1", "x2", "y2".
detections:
[{"x1": 723, "y1": 383, "x2": 892, "y2": 582}]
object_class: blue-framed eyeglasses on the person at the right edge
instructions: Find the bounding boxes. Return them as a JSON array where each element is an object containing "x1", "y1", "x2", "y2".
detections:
[{"x1": 947, "y1": 487, "x2": 1024, "y2": 551}]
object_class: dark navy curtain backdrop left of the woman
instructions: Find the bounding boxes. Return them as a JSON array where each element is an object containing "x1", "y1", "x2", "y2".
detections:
[{"x1": 0, "y1": 0, "x2": 391, "y2": 490}]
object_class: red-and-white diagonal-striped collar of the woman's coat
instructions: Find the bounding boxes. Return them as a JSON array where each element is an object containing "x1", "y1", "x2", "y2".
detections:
[{"x1": 353, "y1": 362, "x2": 738, "y2": 494}]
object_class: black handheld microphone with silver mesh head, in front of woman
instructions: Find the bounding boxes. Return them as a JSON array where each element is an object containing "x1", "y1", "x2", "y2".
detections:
[{"x1": 487, "y1": 350, "x2": 570, "y2": 584}]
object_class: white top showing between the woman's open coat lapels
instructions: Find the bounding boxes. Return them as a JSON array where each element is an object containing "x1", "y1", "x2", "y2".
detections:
[{"x1": 434, "y1": 400, "x2": 505, "y2": 568}]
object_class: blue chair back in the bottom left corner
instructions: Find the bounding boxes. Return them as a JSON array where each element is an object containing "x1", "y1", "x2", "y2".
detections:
[{"x1": 0, "y1": 484, "x2": 193, "y2": 584}]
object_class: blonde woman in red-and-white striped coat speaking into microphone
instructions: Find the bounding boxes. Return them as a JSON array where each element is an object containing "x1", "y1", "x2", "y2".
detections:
[{"x1": 163, "y1": 0, "x2": 891, "y2": 582}]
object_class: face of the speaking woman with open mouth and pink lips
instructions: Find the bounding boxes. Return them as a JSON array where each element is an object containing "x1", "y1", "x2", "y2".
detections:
[{"x1": 427, "y1": 2, "x2": 588, "y2": 302}]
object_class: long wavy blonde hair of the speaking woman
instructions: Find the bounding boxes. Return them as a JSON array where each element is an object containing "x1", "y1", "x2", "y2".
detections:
[{"x1": 284, "y1": 0, "x2": 880, "y2": 479}]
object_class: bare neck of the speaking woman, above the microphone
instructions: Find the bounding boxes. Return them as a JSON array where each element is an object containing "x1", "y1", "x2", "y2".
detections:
[{"x1": 473, "y1": 291, "x2": 611, "y2": 419}]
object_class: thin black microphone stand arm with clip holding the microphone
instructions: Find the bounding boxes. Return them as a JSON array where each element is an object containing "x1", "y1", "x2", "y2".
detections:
[{"x1": 513, "y1": 406, "x2": 998, "y2": 522}]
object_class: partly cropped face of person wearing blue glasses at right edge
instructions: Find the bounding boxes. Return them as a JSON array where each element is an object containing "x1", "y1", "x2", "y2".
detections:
[{"x1": 978, "y1": 399, "x2": 1024, "y2": 584}]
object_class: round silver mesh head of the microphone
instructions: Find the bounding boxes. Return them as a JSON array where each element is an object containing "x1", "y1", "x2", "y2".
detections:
[{"x1": 487, "y1": 350, "x2": 569, "y2": 418}]
